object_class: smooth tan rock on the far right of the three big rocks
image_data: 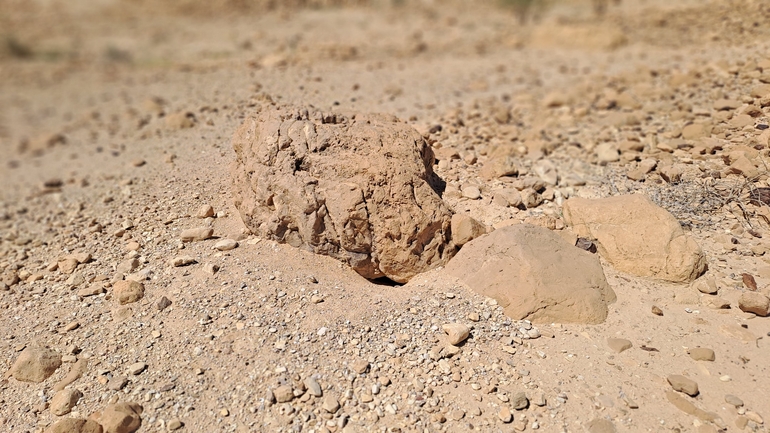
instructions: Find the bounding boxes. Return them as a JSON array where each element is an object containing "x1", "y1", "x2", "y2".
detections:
[{"x1": 563, "y1": 194, "x2": 706, "y2": 282}]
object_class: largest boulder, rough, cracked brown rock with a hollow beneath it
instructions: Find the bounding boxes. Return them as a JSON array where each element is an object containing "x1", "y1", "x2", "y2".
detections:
[{"x1": 232, "y1": 106, "x2": 456, "y2": 283}]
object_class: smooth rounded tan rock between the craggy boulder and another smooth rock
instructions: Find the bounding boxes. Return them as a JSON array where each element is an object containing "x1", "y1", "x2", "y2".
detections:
[{"x1": 445, "y1": 224, "x2": 615, "y2": 323}]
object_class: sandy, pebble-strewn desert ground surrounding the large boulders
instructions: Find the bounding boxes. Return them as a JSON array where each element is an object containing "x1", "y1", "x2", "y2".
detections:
[{"x1": 0, "y1": 0, "x2": 770, "y2": 433}]
